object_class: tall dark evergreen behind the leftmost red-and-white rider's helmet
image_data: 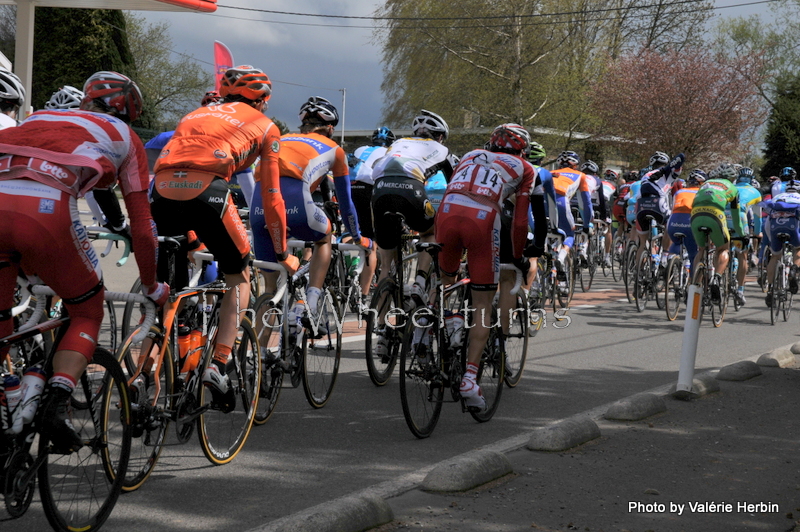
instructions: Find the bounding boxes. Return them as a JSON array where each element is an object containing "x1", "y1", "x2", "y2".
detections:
[{"x1": 30, "y1": 7, "x2": 136, "y2": 109}]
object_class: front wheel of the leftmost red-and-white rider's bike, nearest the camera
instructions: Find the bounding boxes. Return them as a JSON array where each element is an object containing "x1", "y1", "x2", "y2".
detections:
[{"x1": 38, "y1": 347, "x2": 132, "y2": 531}]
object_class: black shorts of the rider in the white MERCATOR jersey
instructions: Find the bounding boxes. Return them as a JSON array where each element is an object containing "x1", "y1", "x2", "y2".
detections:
[{"x1": 372, "y1": 176, "x2": 436, "y2": 249}]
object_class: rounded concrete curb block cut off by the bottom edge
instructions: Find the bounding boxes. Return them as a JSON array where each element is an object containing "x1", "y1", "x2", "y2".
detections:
[{"x1": 248, "y1": 496, "x2": 394, "y2": 532}]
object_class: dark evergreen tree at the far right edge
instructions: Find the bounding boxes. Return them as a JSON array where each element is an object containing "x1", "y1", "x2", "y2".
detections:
[{"x1": 762, "y1": 75, "x2": 800, "y2": 175}]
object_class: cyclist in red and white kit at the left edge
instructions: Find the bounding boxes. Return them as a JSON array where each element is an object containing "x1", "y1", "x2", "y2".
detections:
[{"x1": 0, "y1": 71, "x2": 169, "y2": 452}]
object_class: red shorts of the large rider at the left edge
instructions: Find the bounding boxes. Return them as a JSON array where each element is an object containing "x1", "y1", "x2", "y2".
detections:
[{"x1": 0, "y1": 179, "x2": 105, "y2": 360}]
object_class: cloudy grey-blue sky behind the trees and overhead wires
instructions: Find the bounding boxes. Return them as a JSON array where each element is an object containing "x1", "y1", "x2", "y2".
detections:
[{"x1": 142, "y1": 0, "x2": 780, "y2": 130}]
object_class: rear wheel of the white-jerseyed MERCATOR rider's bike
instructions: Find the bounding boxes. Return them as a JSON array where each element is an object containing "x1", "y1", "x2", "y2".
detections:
[{"x1": 364, "y1": 277, "x2": 405, "y2": 386}]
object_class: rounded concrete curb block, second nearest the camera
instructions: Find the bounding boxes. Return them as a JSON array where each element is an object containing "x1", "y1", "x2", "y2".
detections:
[{"x1": 419, "y1": 451, "x2": 514, "y2": 492}]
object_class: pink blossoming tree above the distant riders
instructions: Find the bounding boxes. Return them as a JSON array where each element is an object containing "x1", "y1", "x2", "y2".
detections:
[{"x1": 591, "y1": 48, "x2": 766, "y2": 165}]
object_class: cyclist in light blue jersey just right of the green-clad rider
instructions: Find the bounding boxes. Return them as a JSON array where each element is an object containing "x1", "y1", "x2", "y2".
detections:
[{"x1": 725, "y1": 167, "x2": 762, "y2": 305}]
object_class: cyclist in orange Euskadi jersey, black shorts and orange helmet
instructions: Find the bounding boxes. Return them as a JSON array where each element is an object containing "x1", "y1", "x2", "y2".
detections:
[{"x1": 151, "y1": 65, "x2": 295, "y2": 410}]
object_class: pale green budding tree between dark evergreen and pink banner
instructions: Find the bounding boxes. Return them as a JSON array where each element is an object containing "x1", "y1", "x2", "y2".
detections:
[{"x1": 125, "y1": 11, "x2": 214, "y2": 130}]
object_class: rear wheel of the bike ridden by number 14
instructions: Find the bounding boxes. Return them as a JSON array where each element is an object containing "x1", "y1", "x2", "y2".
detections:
[{"x1": 400, "y1": 307, "x2": 445, "y2": 438}]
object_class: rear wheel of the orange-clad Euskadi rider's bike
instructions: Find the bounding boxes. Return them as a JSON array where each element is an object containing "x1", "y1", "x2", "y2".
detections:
[{"x1": 111, "y1": 327, "x2": 175, "y2": 492}]
